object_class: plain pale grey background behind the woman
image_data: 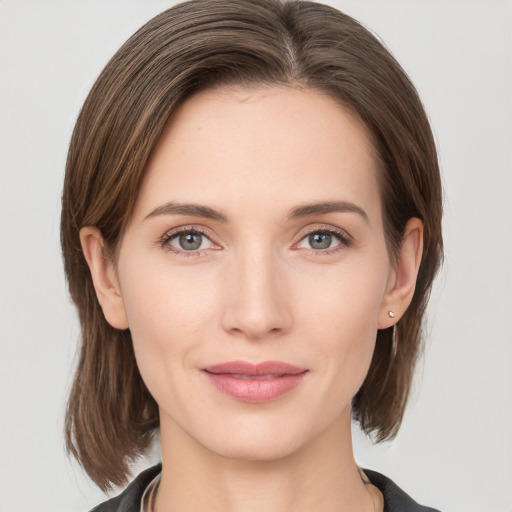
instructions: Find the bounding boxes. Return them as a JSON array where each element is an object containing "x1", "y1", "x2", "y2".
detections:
[{"x1": 0, "y1": 0, "x2": 512, "y2": 512}]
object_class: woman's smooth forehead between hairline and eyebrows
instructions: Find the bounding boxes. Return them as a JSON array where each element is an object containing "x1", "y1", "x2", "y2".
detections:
[{"x1": 136, "y1": 86, "x2": 380, "y2": 224}]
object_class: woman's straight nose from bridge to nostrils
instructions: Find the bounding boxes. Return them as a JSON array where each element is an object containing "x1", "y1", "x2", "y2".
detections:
[{"x1": 222, "y1": 244, "x2": 292, "y2": 341}]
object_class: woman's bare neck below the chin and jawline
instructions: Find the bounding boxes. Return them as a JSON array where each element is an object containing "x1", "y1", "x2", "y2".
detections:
[{"x1": 155, "y1": 413, "x2": 374, "y2": 512}]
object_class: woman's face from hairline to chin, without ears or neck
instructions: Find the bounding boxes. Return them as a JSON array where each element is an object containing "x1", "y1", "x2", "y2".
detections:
[{"x1": 107, "y1": 87, "x2": 395, "y2": 459}]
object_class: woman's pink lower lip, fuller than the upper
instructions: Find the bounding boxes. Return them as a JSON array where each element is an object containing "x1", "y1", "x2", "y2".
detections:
[{"x1": 205, "y1": 372, "x2": 307, "y2": 404}]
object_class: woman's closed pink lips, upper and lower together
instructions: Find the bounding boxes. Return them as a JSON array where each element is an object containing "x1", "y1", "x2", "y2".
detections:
[{"x1": 203, "y1": 361, "x2": 308, "y2": 403}]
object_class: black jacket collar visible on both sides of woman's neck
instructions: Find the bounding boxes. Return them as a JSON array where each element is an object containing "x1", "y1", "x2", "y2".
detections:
[{"x1": 91, "y1": 464, "x2": 439, "y2": 512}]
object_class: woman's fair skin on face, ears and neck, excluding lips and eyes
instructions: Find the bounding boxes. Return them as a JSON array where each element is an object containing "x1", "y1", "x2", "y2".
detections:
[{"x1": 81, "y1": 87, "x2": 422, "y2": 512}]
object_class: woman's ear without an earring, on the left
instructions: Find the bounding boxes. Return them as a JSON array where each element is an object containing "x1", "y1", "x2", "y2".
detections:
[{"x1": 80, "y1": 226, "x2": 128, "y2": 329}]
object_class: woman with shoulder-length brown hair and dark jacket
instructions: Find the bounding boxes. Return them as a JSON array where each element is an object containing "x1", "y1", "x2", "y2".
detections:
[{"x1": 61, "y1": 0, "x2": 442, "y2": 512}]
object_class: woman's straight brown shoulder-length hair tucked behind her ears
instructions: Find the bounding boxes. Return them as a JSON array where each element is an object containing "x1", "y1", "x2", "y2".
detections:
[{"x1": 61, "y1": 0, "x2": 442, "y2": 489}]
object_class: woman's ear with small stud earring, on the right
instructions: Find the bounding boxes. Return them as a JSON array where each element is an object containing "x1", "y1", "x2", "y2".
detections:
[{"x1": 377, "y1": 218, "x2": 423, "y2": 329}]
